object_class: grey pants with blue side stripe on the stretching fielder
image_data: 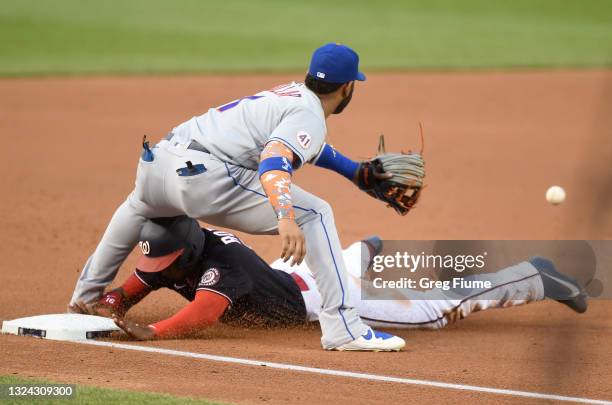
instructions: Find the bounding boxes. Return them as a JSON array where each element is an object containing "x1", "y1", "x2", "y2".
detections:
[{"x1": 71, "y1": 140, "x2": 367, "y2": 348}]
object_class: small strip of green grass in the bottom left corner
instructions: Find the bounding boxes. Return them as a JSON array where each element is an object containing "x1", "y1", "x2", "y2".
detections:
[{"x1": 0, "y1": 375, "x2": 227, "y2": 405}]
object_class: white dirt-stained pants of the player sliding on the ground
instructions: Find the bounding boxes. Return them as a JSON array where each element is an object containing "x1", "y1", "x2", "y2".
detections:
[{"x1": 282, "y1": 241, "x2": 583, "y2": 329}]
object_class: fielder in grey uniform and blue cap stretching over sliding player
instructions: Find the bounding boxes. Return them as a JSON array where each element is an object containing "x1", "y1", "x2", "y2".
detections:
[{"x1": 69, "y1": 44, "x2": 425, "y2": 351}]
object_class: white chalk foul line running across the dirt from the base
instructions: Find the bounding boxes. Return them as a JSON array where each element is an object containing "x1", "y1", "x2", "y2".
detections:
[{"x1": 73, "y1": 340, "x2": 612, "y2": 405}]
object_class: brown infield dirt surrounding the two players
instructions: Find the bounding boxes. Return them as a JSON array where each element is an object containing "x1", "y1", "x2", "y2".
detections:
[{"x1": 0, "y1": 71, "x2": 612, "y2": 404}]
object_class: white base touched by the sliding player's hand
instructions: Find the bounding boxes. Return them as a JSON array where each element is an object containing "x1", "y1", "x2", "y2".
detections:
[{"x1": 2, "y1": 314, "x2": 119, "y2": 340}]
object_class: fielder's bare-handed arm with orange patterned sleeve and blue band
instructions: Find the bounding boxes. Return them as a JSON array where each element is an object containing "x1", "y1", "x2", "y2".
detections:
[{"x1": 259, "y1": 140, "x2": 306, "y2": 265}]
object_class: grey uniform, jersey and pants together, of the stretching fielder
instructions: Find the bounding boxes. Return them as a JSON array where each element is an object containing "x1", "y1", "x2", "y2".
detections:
[{"x1": 71, "y1": 83, "x2": 367, "y2": 348}]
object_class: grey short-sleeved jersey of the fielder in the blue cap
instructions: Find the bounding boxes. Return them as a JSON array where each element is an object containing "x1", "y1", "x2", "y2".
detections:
[{"x1": 172, "y1": 82, "x2": 327, "y2": 170}]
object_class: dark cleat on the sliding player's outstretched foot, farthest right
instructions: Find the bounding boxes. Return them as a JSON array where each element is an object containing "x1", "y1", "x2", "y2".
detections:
[{"x1": 529, "y1": 257, "x2": 588, "y2": 314}]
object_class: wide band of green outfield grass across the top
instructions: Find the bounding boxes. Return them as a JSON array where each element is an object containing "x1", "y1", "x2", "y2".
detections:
[{"x1": 0, "y1": 0, "x2": 612, "y2": 76}]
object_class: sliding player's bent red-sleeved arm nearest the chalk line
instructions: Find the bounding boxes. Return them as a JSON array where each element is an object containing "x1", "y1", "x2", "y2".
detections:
[{"x1": 113, "y1": 290, "x2": 230, "y2": 340}]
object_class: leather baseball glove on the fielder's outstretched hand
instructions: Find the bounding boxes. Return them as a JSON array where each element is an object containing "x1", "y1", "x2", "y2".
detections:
[{"x1": 357, "y1": 135, "x2": 425, "y2": 215}]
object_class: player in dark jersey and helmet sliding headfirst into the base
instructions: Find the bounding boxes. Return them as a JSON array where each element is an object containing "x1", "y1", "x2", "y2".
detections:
[{"x1": 78, "y1": 216, "x2": 587, "y2": 342}]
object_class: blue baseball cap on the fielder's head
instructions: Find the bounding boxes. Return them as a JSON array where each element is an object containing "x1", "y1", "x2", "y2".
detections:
[{"x1": 308, "y1": 43, "x2": 365, "y2": 83}]
